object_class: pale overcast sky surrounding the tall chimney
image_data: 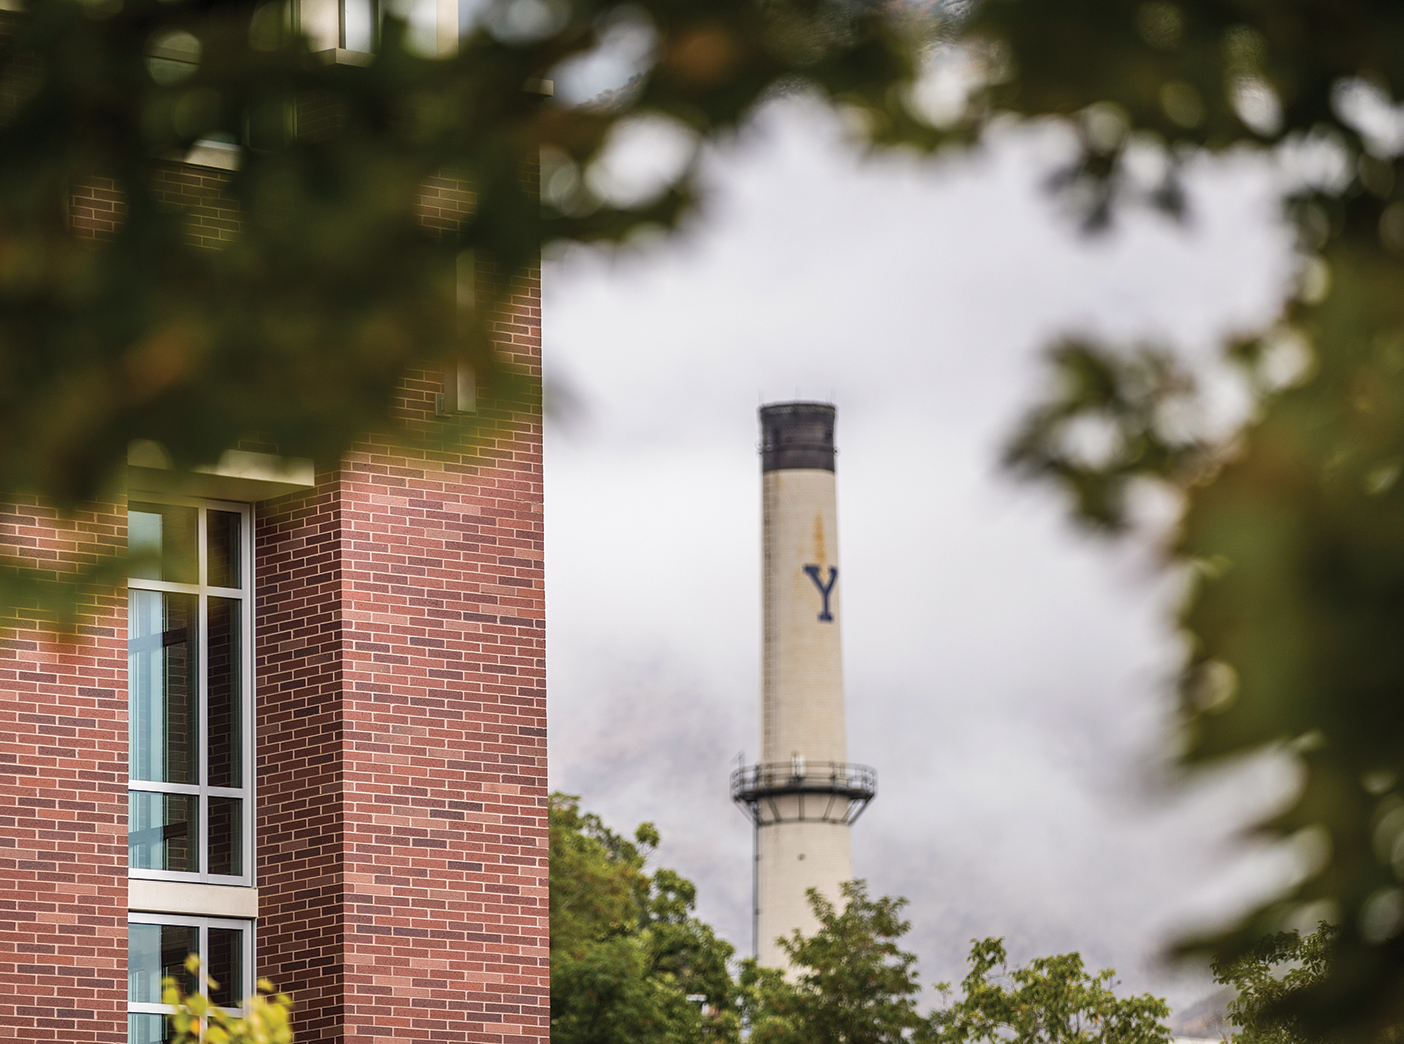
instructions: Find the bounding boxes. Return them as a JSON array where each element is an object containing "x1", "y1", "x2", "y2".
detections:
[{"x1": 545, "y1": 101, "x2": 1290, "y2": 1021}]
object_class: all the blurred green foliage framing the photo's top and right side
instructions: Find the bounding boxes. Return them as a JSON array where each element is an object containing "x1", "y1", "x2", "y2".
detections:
[{"x1": 8, "y1": 0, "x2": 1404, "y2": 1037}]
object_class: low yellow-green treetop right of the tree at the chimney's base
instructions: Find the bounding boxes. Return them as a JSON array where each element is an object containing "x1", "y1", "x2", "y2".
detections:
[{"x1": 915, "y1": 939, "x2": 1170, "y2": 1044}]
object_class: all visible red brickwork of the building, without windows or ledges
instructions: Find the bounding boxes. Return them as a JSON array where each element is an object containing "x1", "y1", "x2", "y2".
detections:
[{"x1": 28, "y1": 134, "x2": 549, "y2": 1044}]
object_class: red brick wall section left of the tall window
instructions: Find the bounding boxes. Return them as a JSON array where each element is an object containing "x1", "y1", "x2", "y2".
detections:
[{"x1": 0, "y1": 501, "x2": 126, "y2": 1044}]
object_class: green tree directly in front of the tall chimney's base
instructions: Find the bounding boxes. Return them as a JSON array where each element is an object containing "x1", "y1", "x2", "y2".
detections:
[{"x1": 741, "y1": 881, "x2": 921, "y2": 1044}]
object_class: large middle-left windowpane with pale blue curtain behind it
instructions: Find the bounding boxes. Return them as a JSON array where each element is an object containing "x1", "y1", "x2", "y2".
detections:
[{"x1": 126, "y1": 591, "x2": 199, "y2": 783}]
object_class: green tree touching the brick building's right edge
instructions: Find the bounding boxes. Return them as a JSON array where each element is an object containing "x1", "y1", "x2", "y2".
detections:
[{"x1": 550, "y1": 794, "x2": 740, "y2": 1044}]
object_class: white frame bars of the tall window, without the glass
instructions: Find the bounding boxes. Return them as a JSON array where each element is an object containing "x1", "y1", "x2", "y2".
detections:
[{"x1": 126, "y1": 493, "x2": 258, "y2": 886}]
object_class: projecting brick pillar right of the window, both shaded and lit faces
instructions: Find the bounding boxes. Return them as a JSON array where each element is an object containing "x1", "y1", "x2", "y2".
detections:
[{"x1": 257, "y1": 265, "x2": 549, "y2": 1041}]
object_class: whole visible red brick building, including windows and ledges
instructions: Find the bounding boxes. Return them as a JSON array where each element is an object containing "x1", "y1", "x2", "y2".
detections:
[{"x1": 0, "y1": 0, "x2": 549, "y2": 1044}]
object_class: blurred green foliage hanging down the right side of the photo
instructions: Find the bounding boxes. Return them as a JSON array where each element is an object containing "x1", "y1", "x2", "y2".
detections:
[{"x1": 972, "y1": 0, "x2": 1404, "y2": 1040}]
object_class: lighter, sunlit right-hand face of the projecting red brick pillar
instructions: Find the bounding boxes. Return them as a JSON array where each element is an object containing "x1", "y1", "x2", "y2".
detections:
[{"x1": 343, "y1": 362, "x2": 549, "y2": 1041}]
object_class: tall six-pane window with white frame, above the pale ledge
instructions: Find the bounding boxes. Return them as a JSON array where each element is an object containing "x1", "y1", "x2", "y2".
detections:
[{"x1": 128, "y1": 501, "x2": 254, "y2": 884}]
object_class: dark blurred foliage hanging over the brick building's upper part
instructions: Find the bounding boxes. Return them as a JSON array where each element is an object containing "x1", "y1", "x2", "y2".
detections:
[{"x1": 0, "y1": 0, "x2": 932, "y2": 507}]
